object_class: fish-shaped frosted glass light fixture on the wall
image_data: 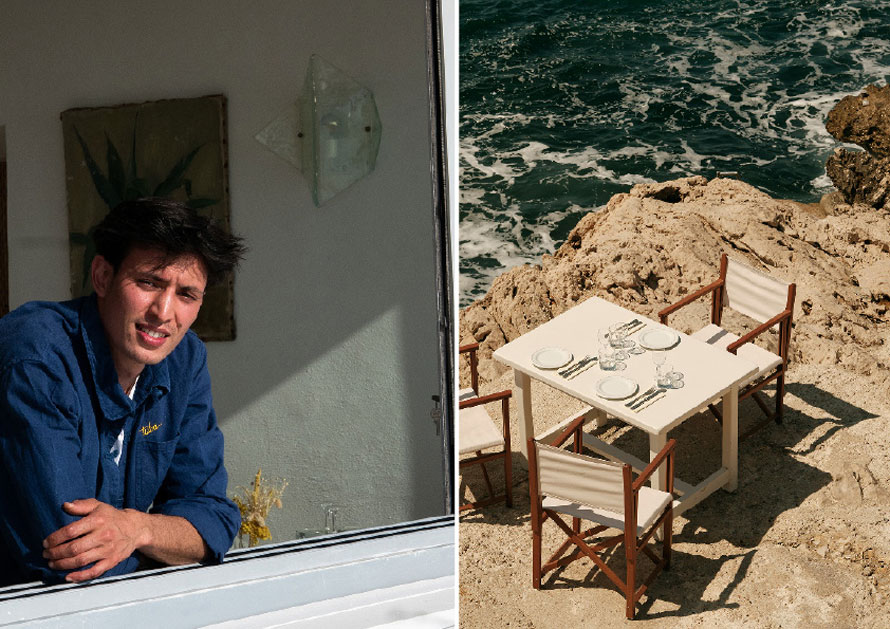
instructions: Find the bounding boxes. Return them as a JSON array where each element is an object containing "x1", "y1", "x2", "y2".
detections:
[{"x1": 256, "y1": 55, "x2": 381, "y2": 206}]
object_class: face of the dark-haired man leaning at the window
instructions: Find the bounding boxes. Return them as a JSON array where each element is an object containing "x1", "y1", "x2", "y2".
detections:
[{"x1": 92, "y1": 247, "x2": 207, "y2": 382}]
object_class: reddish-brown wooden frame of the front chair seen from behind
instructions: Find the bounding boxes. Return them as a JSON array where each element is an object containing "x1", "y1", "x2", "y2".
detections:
[{"x1": 528, "y1": 416, "x2": 677, "y2": 620}]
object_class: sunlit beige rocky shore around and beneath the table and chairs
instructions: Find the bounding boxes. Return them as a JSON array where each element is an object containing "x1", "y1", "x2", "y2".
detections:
[{"x1": 460, "y1": 87, "x2": 890, "y2": 627}]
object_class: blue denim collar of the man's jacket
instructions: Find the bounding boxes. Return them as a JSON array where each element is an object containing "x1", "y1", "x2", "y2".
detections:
[{"x1": 80, "y1": 293, "x2": 170, "y2": 421}]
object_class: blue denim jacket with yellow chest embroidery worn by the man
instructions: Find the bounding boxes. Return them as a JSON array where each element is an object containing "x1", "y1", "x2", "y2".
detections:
[{"x1": 0, "y1": 296, "x2": 240, "y2": 585}]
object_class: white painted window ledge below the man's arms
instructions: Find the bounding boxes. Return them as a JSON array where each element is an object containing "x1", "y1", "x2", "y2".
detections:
[{"x1": 0, "y1": 516, "x2": 456, "y2": 629}]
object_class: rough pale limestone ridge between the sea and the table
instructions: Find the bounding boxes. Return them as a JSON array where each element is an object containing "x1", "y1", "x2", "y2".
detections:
[{"x1": 460, "y1": 177, "x2": 890, "y2": 394}]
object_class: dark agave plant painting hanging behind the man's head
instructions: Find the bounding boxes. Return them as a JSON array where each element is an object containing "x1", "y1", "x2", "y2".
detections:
[{"x1": 61, "y1": 95, "x2": 235, "y2": 341}]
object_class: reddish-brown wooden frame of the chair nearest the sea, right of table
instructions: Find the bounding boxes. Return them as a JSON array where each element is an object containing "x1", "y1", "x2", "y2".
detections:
[{"x1": 658, "y1": 253, "x2": 797, "y2": 441}]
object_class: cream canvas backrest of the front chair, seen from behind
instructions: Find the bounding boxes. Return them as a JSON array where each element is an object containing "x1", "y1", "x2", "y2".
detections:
[{"x1": 535, "y1": 443, "x2": 624, "y2": 514}]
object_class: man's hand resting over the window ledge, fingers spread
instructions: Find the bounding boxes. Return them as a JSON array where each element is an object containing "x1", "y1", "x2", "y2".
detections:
[{"x1": 43, "y1": 498, "x2": 148, "y2": 583}]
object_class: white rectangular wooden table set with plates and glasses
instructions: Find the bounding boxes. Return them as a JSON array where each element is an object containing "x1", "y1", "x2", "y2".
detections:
[{"x1": 494, "y1": 297, "x2": 756, "y2": 513}]
